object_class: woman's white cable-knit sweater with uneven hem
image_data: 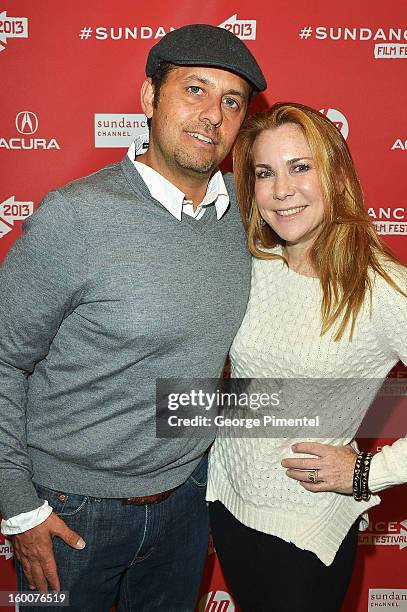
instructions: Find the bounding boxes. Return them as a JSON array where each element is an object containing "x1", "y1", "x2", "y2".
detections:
[{"x1": 207, "y1": 248, "x2": 407, "y2": 565}]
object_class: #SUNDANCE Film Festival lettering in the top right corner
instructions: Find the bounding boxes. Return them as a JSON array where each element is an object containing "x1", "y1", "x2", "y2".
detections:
[{"x1": 298, "y1": 26, "x2": 407, "y2": 59}]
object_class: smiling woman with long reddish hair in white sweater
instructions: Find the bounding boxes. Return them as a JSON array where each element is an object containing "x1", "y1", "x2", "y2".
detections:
[{"x1": 207, "y1": 103, "x2": 407, "y2": 612}]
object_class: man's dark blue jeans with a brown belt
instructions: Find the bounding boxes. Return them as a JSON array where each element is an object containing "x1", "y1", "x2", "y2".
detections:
[{"x1": 17, "y1": 457, "x2": 208, "y2": 612}]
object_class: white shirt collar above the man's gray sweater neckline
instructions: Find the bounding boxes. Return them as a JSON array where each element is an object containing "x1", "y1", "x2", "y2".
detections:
[{"x1": 127, "y1": 132, "x2": 229, "y2": 221}]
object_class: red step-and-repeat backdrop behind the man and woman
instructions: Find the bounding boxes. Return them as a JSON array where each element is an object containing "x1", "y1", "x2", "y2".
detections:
[{"x1": 0, "y1": 0, "x2": 407, "y2": 612}]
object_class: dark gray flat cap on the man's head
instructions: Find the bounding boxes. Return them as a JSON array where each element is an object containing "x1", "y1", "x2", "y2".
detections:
[{"x1": 146, "y1": 23, "x2": 267, "y2": 91}]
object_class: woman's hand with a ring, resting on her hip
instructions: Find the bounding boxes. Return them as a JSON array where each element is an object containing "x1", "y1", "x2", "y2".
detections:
[{"x1": 281, "y1": 442, "x2": 357, "y2": 495}]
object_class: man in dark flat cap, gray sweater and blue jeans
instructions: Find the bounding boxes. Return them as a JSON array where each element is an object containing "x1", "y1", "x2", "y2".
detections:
[{"x1": 0, "y1": 25, "x2": 266, "y2": 612}]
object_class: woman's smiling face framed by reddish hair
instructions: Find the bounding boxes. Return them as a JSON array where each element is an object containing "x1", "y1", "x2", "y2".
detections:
[{"x1": 253, "y1": 123, "x2": 324, "y2": 246}]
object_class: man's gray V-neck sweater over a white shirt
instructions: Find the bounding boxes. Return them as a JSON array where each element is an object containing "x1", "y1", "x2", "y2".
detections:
[{"x1": 0, "y1": 156, "x2": 250, "y2": 519}]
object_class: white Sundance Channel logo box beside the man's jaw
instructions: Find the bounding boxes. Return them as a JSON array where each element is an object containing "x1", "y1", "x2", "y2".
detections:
[{"x1": 95, "y1": 113, "x2": 147, "y2": 148}]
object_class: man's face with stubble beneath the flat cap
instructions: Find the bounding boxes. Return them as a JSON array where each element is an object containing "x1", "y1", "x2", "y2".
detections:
[{"x1": 142, "y1": 66, "x2": 249, "y2": 177}]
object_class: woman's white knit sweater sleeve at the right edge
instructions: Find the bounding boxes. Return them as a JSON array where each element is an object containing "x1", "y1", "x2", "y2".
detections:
[{"x1": 369, "y1": 268, "x2": 407, "y2": 493}]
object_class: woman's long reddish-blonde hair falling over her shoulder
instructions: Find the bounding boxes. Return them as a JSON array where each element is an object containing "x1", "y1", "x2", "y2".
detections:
[{"x1": 233, "y1": 102, "x2": 406, "y2": 340}]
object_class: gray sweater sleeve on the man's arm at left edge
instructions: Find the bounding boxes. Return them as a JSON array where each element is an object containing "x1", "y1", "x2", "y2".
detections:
[{"x1": 0, "y1": 191, "x2": 83, "y2": 519}]
